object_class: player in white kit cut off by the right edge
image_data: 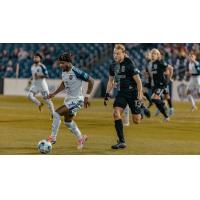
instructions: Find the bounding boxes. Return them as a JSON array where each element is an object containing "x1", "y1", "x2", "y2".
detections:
[{"x1": 187, "y1": 52, "x2": 200, "y2": 111}]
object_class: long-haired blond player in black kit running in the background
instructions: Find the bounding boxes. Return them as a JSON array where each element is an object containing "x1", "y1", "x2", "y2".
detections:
[{"x1": 151, "y1": 49, "x2": 173, "y2": 122}]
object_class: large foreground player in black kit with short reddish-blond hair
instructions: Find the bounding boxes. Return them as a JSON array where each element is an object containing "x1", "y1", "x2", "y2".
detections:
[{"x1": 104, "y1": 44, "x2": 148, "y2": 149}]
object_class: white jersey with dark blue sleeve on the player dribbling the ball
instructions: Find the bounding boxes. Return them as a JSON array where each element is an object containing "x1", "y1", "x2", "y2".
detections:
[{"x1": 62, "y1": 66, "x2": 89, "y2": 100}]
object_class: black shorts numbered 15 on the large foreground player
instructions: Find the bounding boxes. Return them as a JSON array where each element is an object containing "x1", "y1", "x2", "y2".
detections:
[{"x1": 113, "y1": 95, "x2": 141, "y2": 115}]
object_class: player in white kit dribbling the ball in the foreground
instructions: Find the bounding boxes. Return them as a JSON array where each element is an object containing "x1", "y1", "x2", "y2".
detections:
[{"x1": 48, "y1": 52, "x2": 94, "y2": 149}]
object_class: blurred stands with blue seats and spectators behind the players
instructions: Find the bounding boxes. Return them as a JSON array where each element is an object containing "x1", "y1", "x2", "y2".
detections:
[{"x1": 0, "y1": 43, "x2": 200, "y2": 81}]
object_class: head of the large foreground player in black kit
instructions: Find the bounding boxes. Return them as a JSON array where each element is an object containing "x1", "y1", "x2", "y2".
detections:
[{"x1": 113, "y1": 44, "x2": 127, "y2": 63}]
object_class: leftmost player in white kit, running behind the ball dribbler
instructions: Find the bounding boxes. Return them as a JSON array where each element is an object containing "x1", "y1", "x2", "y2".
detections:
[{"x1": 28, "y1": 53, "x2": 54, "y2": 115}]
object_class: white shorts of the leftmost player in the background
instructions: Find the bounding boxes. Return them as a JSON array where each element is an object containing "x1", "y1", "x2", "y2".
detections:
[{"x1": 29, "y1": 82, "x2": 49, "y2": 97}]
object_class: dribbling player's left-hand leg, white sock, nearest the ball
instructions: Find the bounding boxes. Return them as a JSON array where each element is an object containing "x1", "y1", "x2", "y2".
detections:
[{"x1": 48, "y1": 105, "x2": 69, "y2": 144}]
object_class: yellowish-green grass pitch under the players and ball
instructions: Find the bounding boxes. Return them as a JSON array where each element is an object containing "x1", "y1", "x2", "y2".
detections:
[{"x1": 0, "y1": 96, "x2": 200, "y2": 155}]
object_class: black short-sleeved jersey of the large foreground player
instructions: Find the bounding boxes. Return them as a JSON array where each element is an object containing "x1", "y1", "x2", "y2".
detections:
[{"x1": 109, "y1": 58, "x2": 140, "y2": 95}]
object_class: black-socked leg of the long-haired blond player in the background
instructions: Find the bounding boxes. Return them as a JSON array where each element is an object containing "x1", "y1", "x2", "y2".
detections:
[{"x1": 152, "y1": 89, "x2": 169, "y2": 121}]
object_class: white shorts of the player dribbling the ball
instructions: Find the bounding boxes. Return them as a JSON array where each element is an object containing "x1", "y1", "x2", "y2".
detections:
[{"x1": 64, "y1": 98, "x2": 84, "y2": 116}]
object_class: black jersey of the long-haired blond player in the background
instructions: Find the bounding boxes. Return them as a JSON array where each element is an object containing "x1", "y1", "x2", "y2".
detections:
[{"x1": 151, "y1": 60, "x2": 169, "y2": 88}]
